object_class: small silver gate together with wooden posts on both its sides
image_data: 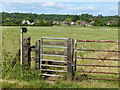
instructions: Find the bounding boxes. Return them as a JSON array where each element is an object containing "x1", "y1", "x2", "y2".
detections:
[{"x1": 22, "y1": 37, "x2": 74, "y2": 80}]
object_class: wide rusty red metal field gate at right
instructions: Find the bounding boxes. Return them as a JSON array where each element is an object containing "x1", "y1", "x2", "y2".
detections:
[{"x1": 75, "y1": 40, "x2": 120, "y2": 81}]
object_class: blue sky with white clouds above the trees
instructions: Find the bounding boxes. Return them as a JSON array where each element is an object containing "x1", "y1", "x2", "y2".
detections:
[{"x1": 0, "y1": 0, "x2": 118, "y2": 16}]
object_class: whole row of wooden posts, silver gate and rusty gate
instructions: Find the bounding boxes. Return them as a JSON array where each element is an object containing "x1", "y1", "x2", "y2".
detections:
[{"x1": 22, "y1": 37, "x2": 120, "y2": 81}]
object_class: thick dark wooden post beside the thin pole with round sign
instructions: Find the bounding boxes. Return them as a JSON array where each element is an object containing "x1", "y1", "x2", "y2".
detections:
[{"x1": 22, "y1": 37, "x2": 30, "y2": 66}]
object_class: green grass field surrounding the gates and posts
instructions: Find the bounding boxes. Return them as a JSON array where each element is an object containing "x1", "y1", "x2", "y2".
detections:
[{"x1": 1, "y1": 26, "x2": 118, "y2": 88}]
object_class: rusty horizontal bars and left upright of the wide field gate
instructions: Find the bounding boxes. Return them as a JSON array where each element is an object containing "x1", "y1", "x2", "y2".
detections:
[{"x1": 74, "y1": 39, "x2": 120, "y2": 81}]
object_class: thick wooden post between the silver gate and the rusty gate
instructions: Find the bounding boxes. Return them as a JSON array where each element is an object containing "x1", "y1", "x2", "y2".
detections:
[{"x1": 67, "y1": 38, "x2": 74, "y2": 81}]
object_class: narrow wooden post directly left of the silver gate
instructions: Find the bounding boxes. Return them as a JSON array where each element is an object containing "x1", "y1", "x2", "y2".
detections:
[{"x1": 35, "y1": 40, "x2": 40, "y2": 69}]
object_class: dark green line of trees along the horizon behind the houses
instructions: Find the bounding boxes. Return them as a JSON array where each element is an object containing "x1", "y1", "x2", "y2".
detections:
[{"x1": 0, "y1": 12, "x2": 120, "y2": 26}]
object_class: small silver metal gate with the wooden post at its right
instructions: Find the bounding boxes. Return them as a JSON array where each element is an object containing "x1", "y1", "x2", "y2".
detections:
[{"x1": 40, "y1": 37, "x2": 74, "y2": 80}]
